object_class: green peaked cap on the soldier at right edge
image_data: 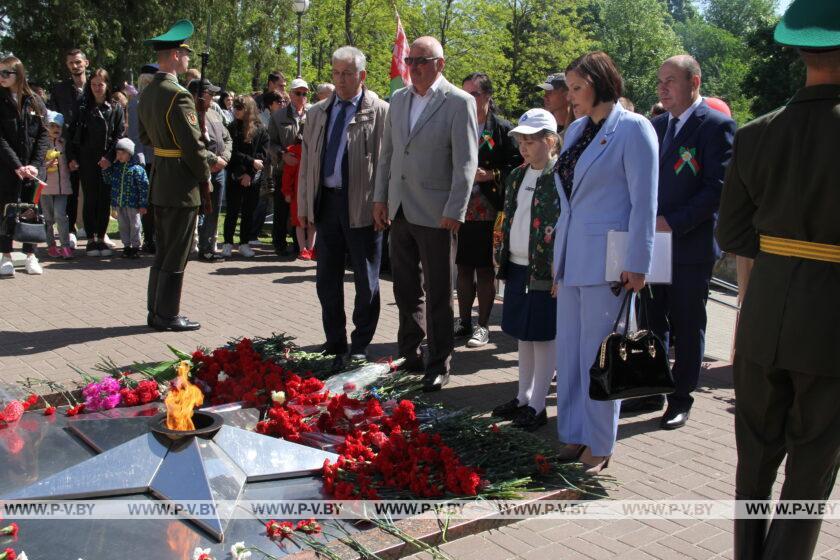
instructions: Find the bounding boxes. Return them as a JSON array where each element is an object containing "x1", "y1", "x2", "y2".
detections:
[{"x1": 773, "y1": 0, "x2": 840, "y2": 49}]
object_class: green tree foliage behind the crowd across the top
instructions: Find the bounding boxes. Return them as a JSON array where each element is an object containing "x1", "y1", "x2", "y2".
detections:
[{"x1": 0, "y1": 0, "x2": 803, "y2": 123}]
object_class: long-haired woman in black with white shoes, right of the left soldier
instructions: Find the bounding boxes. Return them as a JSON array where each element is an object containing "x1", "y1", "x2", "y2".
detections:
[{"x1": 222, "y1": 95, "x2": 268, "y2": 258}]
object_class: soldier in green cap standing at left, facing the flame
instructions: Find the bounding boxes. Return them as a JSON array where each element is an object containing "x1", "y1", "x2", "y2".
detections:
[{"x1": 137, "y1": 20, "x2": 211, "y2": 331}]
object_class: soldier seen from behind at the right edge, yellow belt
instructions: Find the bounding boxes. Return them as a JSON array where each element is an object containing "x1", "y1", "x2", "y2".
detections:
[{"x1": 717, "y1": 0, "x2": 840, "y2": 560}]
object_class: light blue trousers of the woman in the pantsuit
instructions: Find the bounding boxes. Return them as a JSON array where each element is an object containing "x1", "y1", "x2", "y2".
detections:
[{"x1": 557, "y1": 282, "x2": 621, "y2": 457}]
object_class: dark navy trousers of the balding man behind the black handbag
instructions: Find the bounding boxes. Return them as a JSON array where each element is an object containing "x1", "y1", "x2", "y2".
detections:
[{"x1": 647, "y1": 263, "x2": 714, "y2": 410}]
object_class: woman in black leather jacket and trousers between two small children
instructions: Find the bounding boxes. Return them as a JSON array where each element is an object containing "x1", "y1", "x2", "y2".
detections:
[{"x1": 67, "y1": 68, "x2": 125, "y2": 257}]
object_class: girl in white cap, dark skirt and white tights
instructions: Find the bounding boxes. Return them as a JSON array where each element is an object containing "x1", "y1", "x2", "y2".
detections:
[{"x1": 493, "y1": 109, "x2": 560, "y2": 431}]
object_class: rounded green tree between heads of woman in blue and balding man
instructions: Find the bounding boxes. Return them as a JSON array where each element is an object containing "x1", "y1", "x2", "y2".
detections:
[{"x1": 598, "y1": 0, "x2": 682, "y2": 110}]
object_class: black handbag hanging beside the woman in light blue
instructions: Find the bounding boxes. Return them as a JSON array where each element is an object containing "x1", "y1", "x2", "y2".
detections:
[{"x1": 589, "y1": 288, "x2": 675, "y2": 401}]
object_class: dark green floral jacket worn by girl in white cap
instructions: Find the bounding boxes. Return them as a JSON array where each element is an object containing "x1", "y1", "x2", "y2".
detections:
[{"x1": 497, "y1": 157, "x2": 560, "y2": 292}]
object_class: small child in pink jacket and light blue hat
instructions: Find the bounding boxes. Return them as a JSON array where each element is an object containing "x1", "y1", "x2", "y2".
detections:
[{"x1": 40, "y1": 111, "x2": 73, "y2": 259}]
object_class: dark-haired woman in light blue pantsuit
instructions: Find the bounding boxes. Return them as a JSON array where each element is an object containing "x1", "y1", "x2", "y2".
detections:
[{"x1": 553, "y1": 52, "x2": 659, "y2": 474}]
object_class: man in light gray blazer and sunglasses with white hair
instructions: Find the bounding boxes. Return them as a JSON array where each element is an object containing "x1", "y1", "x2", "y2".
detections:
[{"x1": 373, "y1": 37, "x2": 478, "y2": 391}]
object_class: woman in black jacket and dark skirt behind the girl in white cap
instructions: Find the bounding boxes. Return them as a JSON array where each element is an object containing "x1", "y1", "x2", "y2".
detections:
[{"x1": 455, "y1": 72, "x2": 522, "y2": 348}]
